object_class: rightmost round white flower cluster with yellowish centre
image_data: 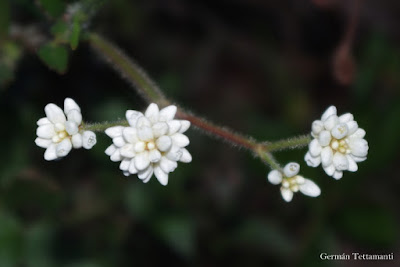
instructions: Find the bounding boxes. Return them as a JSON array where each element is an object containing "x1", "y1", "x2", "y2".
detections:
[{"x1": 304, "y1": 106, "x2": 368, "y2": 179}]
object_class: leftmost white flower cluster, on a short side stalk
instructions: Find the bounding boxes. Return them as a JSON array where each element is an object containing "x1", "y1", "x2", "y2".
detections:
[{"x1": 35, "y1": 98, "x2": 96, "y2": 160}]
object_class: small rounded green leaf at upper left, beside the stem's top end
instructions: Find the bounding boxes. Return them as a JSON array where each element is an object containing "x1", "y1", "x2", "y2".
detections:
[{"x1": 38, "y1": 44, "x2": 68, "y2": 73}]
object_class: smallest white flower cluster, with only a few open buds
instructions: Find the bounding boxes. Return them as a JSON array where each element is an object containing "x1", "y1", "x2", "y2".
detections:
[{"x1": 268, "y1": 162, "x2": 321, "y2": 202}]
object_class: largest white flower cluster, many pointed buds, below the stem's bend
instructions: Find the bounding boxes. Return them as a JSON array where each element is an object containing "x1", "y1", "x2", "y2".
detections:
[{"x1": 105, "y1": 103, "x2": 192, "y2": 185}]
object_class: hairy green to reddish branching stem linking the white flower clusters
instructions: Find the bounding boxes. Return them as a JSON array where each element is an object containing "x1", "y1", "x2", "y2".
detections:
[{"x1": 85, "y1": 33, "x2": 311, "y2": 169}]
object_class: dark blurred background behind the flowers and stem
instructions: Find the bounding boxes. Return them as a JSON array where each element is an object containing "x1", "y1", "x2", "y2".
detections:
[{"x1": 0, "y1": 0, "x2": 400, "y2": 267}]
